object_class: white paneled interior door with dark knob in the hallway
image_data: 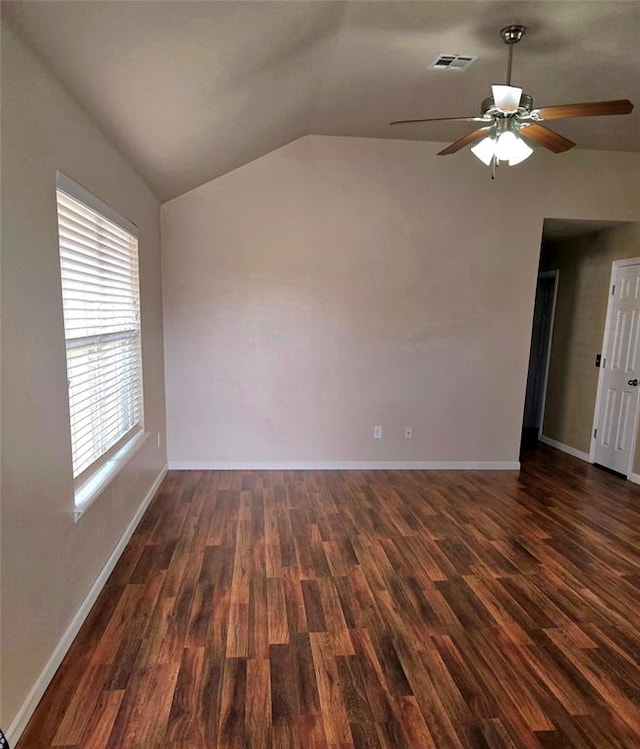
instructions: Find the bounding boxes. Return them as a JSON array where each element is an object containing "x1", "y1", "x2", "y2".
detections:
[{"x1": 593, "y1": 260, "x2": 640, "y2": 475}]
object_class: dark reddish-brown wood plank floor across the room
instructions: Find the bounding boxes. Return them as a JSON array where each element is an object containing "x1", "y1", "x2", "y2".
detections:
[{"x1": 19, "y1": 448, "x2": 640, "y2": 749}]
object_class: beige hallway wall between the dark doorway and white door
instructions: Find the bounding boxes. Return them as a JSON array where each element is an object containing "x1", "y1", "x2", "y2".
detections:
[{"x1": 541, "y1": 219, "x2": 640, "y2": 453}]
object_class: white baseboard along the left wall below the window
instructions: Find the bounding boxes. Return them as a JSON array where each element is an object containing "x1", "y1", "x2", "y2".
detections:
[{"x1": 5, "y1": 466, "x2": 167, "y2": 746}]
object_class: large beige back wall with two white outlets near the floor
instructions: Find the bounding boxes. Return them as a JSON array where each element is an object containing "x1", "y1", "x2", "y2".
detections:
[{"x1": 162, "y1": 136, "x2": 640, "y2": 464}]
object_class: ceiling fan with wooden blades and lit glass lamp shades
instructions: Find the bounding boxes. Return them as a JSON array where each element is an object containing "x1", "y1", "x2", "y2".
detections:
[{"x1": 389, "y1": 24, "x2": 633, "y2": 173}]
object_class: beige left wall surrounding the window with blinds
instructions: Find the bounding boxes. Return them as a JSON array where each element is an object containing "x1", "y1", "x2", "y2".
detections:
[{"x1": 0, "y1": 28, "x2": 165, "y2": 730}]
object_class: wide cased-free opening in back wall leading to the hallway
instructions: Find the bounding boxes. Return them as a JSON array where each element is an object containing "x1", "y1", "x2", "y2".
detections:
[{"x1": 522, "y1": 219, "x2": 640, "y2": 474}]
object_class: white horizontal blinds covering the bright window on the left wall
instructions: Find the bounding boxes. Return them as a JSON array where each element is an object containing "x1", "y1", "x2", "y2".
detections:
[{"x1": 57, "y1": 174, "x2": 143, "y2": 483}]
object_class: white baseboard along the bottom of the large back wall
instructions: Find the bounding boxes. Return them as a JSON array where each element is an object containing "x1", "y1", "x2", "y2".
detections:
[{"x1": 169, "y1": 460, "x2": 520, "y2": 471}]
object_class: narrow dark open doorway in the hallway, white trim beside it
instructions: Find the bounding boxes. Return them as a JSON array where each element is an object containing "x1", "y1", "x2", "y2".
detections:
[{"x1": 520, "y1": 270, "x2": 558, "y2": 451}]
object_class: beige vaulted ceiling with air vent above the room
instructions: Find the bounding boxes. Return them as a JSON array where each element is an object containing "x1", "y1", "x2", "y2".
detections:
[{"x1": 2, "y1": 0, "x2": 640, "y2": 199}]
